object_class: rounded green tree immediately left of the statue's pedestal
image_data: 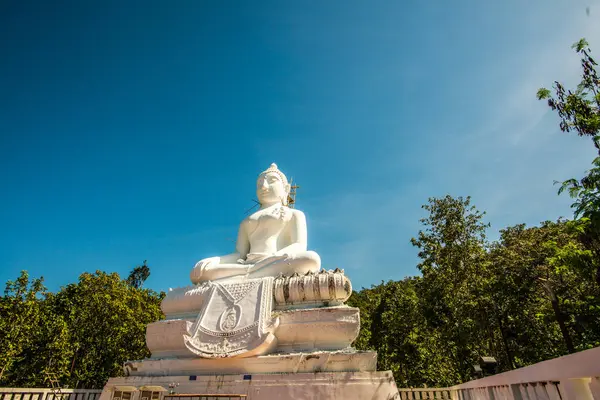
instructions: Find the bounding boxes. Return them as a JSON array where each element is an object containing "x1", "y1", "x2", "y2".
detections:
[{"x1": 54, "y1": 271, "x2": 163, "y2": 388}]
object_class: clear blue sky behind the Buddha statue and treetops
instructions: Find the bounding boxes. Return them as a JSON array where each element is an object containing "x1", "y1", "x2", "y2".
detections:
[{"x1": 0, "y1": 0, "x2": 600, "y2": 290}]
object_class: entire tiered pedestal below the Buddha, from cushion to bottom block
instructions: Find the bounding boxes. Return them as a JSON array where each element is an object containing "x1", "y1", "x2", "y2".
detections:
[{"x1": 100, "y1": 269, "x2": 399, "y2": 400}]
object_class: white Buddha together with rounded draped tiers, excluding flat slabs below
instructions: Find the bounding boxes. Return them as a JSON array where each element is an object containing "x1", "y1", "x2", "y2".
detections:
[{"x1": 146, "y1": 164, "x2": 360, "y2": 359}]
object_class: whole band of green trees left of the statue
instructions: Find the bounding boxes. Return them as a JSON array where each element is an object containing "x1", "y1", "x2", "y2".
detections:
[{"x1": 0, "y1": 271, "x2": 164, "y2": 388}]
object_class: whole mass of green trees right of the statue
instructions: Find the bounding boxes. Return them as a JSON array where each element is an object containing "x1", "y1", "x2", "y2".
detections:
[{"x1": 349, "y1": 196, "x2": 600, "y2": 387}]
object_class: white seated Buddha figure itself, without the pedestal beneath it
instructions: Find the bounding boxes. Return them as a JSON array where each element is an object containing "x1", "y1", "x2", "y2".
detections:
[{"x1": 190, "y1": 164, "x2": 321, "y2": 284}]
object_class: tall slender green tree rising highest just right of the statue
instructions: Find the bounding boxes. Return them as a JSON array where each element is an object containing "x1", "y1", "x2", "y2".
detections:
[{"x1": 411, "y1": 196, "x2": 492, "y2": 381}]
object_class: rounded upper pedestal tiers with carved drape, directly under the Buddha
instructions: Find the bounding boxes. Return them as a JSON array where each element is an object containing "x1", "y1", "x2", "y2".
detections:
[{"x1": 144, "y1": 269, "x2": 360, "y2": 360}]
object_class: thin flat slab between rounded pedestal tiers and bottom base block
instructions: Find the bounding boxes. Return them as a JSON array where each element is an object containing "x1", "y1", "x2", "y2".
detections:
[{"x1": 124, "y1": 351, "x2": 377, "y2": 377}]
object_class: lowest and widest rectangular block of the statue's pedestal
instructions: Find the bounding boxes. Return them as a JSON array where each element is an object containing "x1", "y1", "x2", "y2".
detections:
[{"x1": 99, "y1": 371, "x2": 400, "y2": 400}]
